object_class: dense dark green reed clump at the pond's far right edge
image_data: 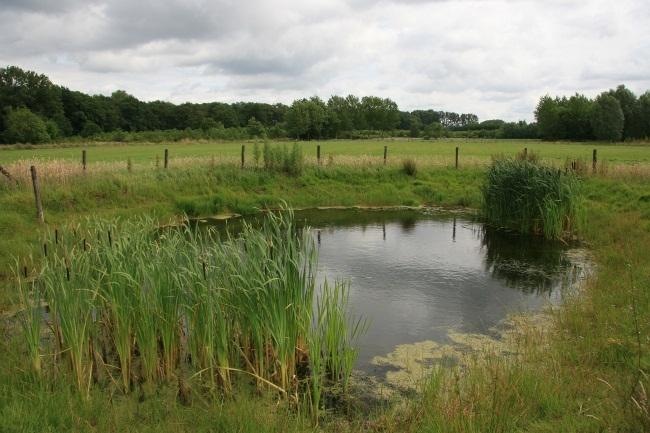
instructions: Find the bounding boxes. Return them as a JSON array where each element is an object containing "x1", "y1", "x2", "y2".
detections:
[{"x1": 482, "y1": 158, "x2": 583, "y2": 239}]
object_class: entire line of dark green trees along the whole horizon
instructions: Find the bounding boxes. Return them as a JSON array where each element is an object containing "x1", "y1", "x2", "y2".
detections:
[{"x1": 0, "y1": 66, "x2": 650, "y2": 143}]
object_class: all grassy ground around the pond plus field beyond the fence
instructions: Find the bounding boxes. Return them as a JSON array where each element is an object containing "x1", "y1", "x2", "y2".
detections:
[{"x1": 0, "y1": 140, "x2": 650, "y2": 433}]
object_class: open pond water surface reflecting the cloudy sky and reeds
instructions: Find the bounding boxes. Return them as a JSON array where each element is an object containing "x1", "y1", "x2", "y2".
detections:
[{"x1": 202, "y1": 209, "x2": 583, "y2": 373}]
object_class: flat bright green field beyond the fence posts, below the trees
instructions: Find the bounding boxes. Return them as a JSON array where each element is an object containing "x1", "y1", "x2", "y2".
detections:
[{"x1": 0, "y1": 139, "x2": 650, "y2": 165}]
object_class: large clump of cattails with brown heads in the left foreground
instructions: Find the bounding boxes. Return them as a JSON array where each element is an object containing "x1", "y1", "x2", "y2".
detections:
[{"x1": 17, "y1": 211, "x2": 363, "y2": 416}]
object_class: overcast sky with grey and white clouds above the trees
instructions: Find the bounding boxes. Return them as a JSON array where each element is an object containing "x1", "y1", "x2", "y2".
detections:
[{"x1": 0, "y1": 0, "x2": 650, "y2": 120}]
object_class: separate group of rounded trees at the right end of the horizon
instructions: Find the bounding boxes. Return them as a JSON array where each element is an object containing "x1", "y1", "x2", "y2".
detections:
[{"x1": 535, "y1": 85, "x2": 650, "y2": 141}]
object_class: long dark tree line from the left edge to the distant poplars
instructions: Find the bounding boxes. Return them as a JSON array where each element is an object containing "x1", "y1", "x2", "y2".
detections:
[{"x1": 0, "y1": 66, "x2": 478, "y2": 143}]
